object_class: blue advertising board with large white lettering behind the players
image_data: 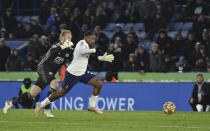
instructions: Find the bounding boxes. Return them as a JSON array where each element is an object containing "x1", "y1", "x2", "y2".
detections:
[{"x1": 0, "y1": 82, "x2": 193, "y2": 111}]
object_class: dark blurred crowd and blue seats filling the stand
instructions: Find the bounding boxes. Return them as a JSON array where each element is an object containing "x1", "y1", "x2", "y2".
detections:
[{"x1": 0, "y1": 0, "x2": 210, "y2": 73}]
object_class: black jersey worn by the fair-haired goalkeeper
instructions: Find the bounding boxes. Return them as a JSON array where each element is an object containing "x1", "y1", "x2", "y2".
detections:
[{"x1": 38, "y1": 43, "x2": 73, "y2": 74}]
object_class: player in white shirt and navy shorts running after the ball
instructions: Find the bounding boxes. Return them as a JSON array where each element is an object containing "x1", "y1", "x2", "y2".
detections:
[{"x1": 35, "y1": 32, "x2": 114, "y2": 115}]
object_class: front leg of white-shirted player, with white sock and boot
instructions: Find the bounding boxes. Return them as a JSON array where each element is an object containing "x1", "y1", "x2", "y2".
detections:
[{"x1": 88, "y1": 77, "x2": 103, "y2": 114}]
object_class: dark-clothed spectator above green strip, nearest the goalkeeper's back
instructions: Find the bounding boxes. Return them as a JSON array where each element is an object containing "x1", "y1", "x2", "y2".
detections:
[{"x1": 23, "y1": 53, "x2": 38, "y2": 71}]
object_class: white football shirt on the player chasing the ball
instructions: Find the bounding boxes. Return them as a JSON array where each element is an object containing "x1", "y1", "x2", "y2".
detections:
[{"x1": 67, "y1": 40, "x2": 96, "y2": 76}]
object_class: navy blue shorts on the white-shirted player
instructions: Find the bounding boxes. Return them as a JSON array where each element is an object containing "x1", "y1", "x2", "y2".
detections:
[{"x1": 62, "y1": 71, "x2": 95, "y2": 91}]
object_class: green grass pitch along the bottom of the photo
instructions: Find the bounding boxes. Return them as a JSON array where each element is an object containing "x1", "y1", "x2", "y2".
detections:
[{"x1": 0, "y1": 109, "x2": 210, "y2": 131}]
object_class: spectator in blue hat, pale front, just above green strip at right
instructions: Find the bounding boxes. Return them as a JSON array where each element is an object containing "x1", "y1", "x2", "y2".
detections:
[{"x1": 173, "y1": 56, "x2": 191, "y2": 73}]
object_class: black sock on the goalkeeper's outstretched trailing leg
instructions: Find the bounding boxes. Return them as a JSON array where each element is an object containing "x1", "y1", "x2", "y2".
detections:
[{"x1": 12, "y1": 92, "x2": 33, "y2": 105}]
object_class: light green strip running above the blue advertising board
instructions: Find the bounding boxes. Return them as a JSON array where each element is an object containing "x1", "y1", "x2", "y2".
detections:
[{"x1": 0, "y1": 72, "x2": 210, "y2": 82}]
